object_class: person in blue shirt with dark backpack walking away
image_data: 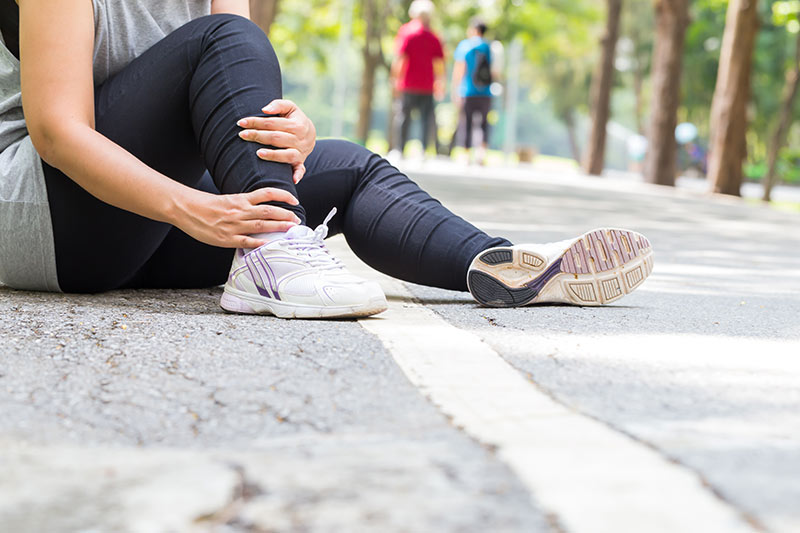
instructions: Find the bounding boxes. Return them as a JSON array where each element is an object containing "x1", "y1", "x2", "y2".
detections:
[{"x1": 452, "y1": 19, "x2": 493, "y2": 164}]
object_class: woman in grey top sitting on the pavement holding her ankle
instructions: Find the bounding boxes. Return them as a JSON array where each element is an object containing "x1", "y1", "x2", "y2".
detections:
[{"x1": 0, "y1": 0, "x2": 652, "y2": 317}]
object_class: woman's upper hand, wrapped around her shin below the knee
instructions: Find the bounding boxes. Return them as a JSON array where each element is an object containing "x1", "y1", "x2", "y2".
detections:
[{"x1": 237, "y1": 100, "x2": 317, "y2": 183}]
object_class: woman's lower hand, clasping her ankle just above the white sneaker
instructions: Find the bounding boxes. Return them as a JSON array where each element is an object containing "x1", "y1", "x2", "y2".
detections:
[{"x1": 172, "y1": 187, "x2": 300, "y2": 248}]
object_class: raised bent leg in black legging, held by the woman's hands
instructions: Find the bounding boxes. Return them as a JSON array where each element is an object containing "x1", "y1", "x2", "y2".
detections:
[{"x1": 45, "y1": 15, "x2": 296, "y2": 292}]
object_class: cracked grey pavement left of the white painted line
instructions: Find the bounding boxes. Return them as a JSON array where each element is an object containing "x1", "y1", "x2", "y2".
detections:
[{"x1": 0, "y1": 282, "x2": 549, "y2": 533}]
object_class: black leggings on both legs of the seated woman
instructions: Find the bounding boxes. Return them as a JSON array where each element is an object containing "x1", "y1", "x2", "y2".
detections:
[{"x1": 45, "y1": 15, "x2": 509, "y2": 292}]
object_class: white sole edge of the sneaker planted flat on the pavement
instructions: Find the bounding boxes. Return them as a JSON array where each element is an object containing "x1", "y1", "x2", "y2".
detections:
[{"x1": 219, "y1": 287, "x2": 387, "y2": 318}]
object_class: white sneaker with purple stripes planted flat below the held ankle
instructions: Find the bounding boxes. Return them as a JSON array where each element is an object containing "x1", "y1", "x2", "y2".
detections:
[{"x1": 220, "y1": 208, "x2": 387, "y2": 318}]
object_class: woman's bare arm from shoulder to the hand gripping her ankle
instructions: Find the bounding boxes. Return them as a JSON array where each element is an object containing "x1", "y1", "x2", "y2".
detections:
[{"x1": 20, "y1": 0, "x2": 297, "y2": 248}]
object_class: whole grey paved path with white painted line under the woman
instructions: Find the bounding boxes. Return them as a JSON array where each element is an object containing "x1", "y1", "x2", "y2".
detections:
[{"x1": 0, "y1": 164, "x2": 800, "y2": 533}]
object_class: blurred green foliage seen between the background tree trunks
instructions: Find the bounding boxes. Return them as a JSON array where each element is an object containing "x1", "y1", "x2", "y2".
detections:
[{"x1": 260, "y1": 0, "x2": 800, "y2": 179}]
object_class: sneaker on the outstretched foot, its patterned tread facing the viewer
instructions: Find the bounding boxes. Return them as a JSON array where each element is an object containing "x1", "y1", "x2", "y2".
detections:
[{"x1": 467, "y1": 229, "x2": 653, "y2": 307}]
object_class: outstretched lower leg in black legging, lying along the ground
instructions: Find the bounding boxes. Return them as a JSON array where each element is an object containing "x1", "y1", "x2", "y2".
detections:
[{"x1": 297, "y1": 140, "x2": 510, "y2": 291}]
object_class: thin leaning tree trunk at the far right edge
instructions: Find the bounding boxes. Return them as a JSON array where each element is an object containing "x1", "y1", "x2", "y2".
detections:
[{"x1": 763, "y1": 2, "x2": 800, "y2": 202}]
